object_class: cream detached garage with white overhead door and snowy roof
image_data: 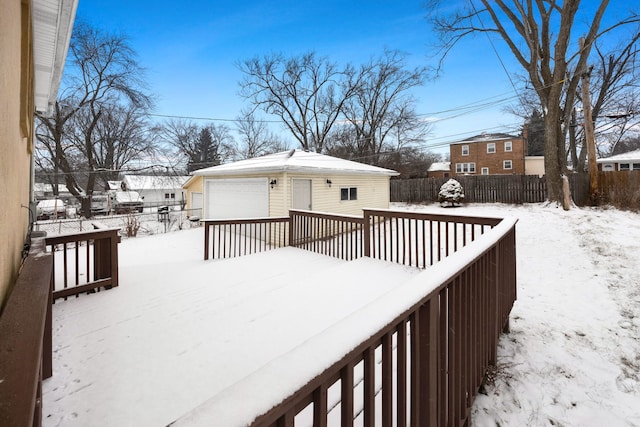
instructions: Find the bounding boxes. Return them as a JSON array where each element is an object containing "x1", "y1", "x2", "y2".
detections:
[{"x1": 184, "y1": 150, "x2": 398, "y2": 219}]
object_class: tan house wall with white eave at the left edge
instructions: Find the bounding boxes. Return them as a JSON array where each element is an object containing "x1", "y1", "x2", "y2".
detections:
[{"x1": 0, "y1": 0, "x2": 77, "y2": 313}]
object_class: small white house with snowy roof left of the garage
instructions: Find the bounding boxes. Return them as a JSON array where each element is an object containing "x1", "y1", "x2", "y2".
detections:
[{"x1": 122, "y1": 175, "x2": 189, "y2": 207}]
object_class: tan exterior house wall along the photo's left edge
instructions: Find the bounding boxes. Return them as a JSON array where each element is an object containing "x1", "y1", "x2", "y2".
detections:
[{"x1": 0, "y1": 0, "x2": 34, "y2": 312}]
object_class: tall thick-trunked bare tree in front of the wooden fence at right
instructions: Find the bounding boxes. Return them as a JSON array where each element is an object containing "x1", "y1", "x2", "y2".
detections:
[{"x1": 428, "y1": 0, "x2": 631, "y2": 209}]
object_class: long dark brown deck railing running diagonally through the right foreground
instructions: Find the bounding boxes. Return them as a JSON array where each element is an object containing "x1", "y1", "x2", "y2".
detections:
[{"x1": 252, "y1": 220, "x2": 516, "y2": 427}]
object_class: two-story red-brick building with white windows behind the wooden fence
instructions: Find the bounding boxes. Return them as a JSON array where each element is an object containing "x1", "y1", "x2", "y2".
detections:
[{"x1": 449, "y1": 133, "x2": 527, "y2": 176}]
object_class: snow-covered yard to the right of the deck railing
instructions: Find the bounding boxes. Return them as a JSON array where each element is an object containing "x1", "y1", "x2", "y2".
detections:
[{"x1": 394, "y1": 204, "x2": 640, "y2": 427}]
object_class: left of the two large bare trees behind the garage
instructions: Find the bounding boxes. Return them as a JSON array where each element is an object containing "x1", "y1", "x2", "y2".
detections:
[{"x1": 238, "y1": 52, "x2": 354, "y2": 153}]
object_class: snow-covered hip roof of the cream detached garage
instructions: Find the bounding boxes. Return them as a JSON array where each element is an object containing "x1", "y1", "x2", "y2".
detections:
[{"x1": 193, "y1": 150, "x2": 399, "y2": 176}]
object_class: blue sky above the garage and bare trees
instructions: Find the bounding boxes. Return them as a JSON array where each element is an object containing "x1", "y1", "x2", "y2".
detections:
[{"x1": 77, "y1": 0, "x2": 632, "y2": 157}]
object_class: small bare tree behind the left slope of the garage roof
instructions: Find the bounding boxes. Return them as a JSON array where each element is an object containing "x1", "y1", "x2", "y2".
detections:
[{"x1": 236, "y1": 111, "x2": 287, "y2": 159}]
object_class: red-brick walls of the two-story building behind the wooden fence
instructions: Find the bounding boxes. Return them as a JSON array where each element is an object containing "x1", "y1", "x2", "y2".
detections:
[{"x1": 450, "y1": 138, "x2": 526, "y2": 176}]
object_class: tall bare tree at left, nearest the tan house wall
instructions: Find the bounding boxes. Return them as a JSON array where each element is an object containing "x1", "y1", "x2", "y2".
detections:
[{"x1": 36, "y1": 23, "x2": 153, "y2": 215}]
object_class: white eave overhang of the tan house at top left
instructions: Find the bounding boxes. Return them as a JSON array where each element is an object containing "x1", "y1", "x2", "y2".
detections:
[{"x1": 31, "y1": 0, "x2": 78, "y2": 113}]
